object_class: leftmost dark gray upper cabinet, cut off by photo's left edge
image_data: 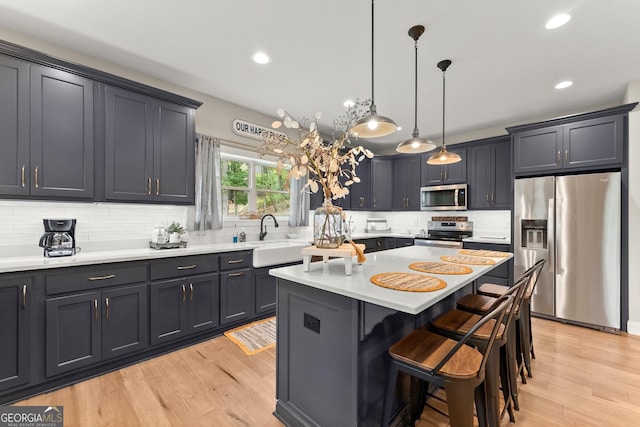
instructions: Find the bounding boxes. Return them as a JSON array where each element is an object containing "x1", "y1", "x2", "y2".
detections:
[{"x1": 0, "y1": 56, "x2": 94, "y2": 199}]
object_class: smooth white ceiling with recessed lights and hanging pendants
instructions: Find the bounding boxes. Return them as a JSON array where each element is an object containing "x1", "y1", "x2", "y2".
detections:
[{"x1": 0, "y1": 0, "x2": 640, "y2": 154}]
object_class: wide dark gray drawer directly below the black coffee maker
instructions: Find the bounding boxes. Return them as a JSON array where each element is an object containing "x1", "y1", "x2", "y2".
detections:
[{"x1": 46, "y1": 263, "x2": 147, "y2": 295}]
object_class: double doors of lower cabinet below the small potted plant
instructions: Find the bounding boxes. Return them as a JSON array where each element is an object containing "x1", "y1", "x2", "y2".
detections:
[{"x1": 149, "y1": 273, "x2": 219, "y2": 345}]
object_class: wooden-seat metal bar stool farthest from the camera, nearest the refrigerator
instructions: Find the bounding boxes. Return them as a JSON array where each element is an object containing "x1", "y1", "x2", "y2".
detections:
[{"x1": 477, "y1": 259, "x2": 546, "y2": 382}]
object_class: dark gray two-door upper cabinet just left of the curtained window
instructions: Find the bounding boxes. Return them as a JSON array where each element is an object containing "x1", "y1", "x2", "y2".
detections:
[{"x1": 105, "y1": 87, "x2": 195, "y2": 204}]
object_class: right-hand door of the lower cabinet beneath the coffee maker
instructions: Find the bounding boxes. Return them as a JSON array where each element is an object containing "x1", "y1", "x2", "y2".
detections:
[{"x1": 102, "y1": 285, "x2": 149, "y2": 360}]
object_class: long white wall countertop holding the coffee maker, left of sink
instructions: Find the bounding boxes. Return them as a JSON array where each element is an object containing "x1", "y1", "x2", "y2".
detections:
[{"x1": 0, "y1": 242, "x2": 258, "y2": 273}]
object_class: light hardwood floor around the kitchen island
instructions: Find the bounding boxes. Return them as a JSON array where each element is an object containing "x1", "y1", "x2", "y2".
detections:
[{"x1": 17, "y1": 319, "x2": 640, "y2": 427}]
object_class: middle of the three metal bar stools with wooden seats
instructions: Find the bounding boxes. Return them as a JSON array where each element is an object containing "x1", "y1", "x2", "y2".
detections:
[{"x1": 430, "y1": 277, "x2": 528, "y2": 426}]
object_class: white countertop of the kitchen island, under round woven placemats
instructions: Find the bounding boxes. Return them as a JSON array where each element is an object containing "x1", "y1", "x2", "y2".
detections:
[{"x1": 269, "y1": 246, "x2": 512, "y2": 314}]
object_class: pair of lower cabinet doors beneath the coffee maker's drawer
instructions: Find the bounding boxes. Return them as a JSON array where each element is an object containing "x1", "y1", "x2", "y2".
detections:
[{"x1": 45, "y1": 284, "x2": 149, "y2": 377}]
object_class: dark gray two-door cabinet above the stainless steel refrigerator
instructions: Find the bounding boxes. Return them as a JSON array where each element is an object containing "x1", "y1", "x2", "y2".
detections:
[{"x1": 507, "y1": 104, "x2": 635, "y2": 176}]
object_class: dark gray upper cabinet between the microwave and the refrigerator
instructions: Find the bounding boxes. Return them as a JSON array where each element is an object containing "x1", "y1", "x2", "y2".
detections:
[{"x1": 467, "y1": 137, "x2": 512, "y2": 209}]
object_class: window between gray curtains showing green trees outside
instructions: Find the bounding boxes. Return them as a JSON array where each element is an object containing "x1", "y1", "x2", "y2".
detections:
[{"x1": 220, "y1": 154, "x2": 289, "y2": 216}]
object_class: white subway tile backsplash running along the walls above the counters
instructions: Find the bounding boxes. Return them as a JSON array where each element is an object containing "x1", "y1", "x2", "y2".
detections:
[{"x1": 0, "y1": 200, "x2": 511, "y2": 256}]
